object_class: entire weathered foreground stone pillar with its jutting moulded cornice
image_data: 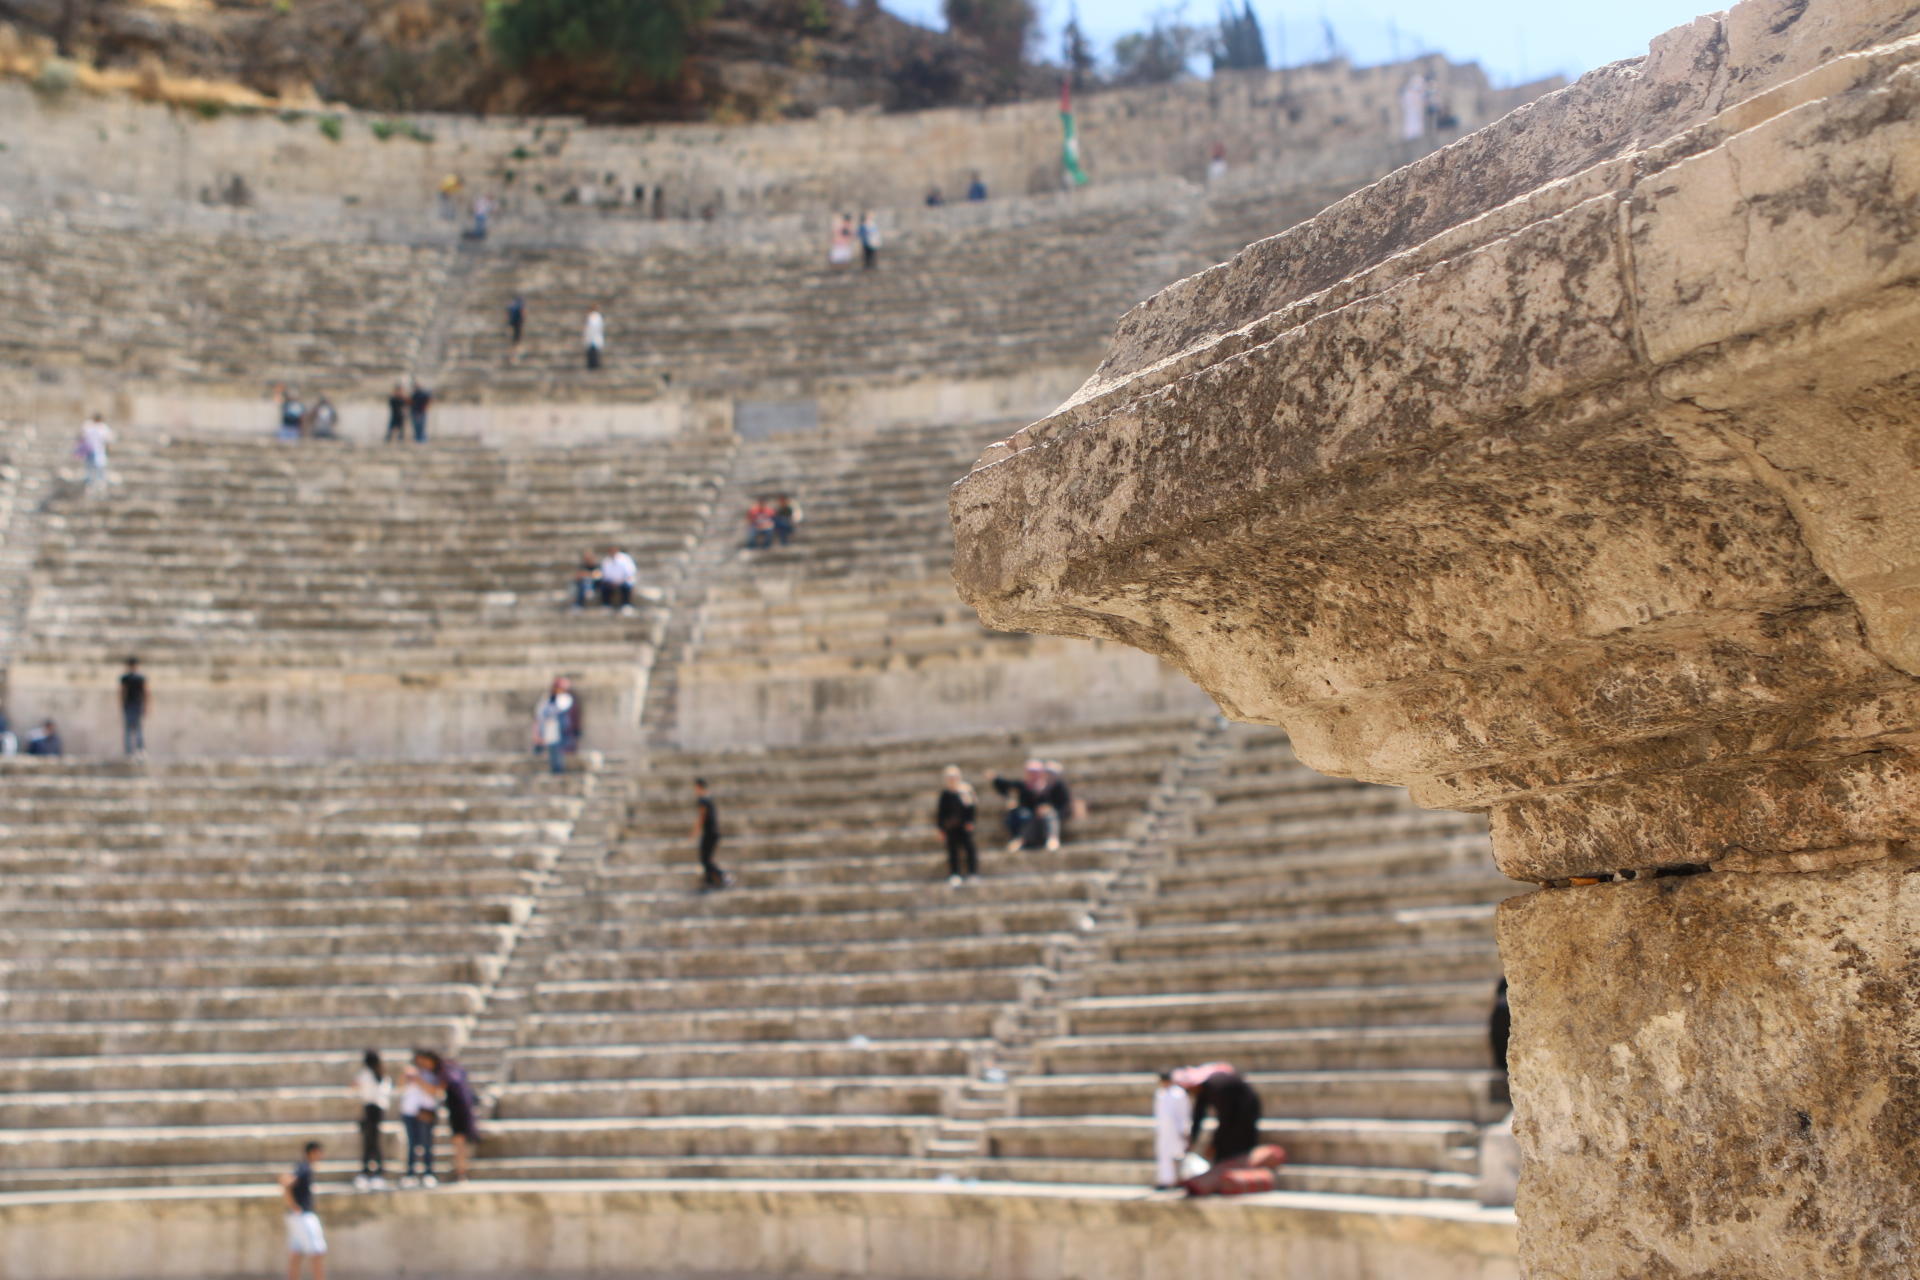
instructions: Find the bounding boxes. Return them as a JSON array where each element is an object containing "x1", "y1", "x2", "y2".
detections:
[{"x1": 952, "y1": 0, "x2": 1920, "y2": 1278}]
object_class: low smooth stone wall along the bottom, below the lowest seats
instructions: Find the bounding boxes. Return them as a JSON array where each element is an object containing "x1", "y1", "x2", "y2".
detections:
[{"x1": 0, "y1": 1182, "x2": 1517, "y2": 1280}]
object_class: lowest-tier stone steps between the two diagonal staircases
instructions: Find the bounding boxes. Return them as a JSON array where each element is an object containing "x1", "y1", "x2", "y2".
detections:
[{"x1": 490, "y1": 722, "x2": 1192, "y2": 1176}]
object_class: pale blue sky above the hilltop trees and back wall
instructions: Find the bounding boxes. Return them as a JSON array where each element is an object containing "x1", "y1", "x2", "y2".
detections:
[{"x1": 885, "y1": 0, "x2": 1724, "y2": 84}]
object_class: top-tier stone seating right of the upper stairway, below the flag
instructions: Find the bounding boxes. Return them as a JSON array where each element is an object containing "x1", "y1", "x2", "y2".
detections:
[{"x1": 444, "y1": 209, "x2": 1179, "y2": 397}]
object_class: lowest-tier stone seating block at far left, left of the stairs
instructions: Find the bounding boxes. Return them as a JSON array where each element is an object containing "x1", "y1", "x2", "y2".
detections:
[{"x1": 0, "y1": 760, "x2": 586, "y2": 1190}]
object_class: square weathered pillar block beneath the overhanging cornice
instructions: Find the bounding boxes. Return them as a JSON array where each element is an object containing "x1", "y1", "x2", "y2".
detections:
[{"x1": 1500, "y1": 858, "x2": 1920, "y2": 1280}]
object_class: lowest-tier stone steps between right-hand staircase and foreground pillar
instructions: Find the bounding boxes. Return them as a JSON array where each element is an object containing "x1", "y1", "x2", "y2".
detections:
[{"x1": 987, "y1": 727, "x2": 1515, "y2": 1196}]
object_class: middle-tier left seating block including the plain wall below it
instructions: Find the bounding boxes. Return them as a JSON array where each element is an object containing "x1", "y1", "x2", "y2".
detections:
[{"x1": 10, "y1": 432, "x2": 730, "y2": 756}]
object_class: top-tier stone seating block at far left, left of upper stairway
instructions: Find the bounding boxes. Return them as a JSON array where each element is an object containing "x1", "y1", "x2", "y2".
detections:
[{"x1": 0, "y1": 223, "x2": 447, "y2": 395}]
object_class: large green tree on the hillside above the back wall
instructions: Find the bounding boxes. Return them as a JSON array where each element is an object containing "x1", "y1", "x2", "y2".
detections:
[{"x1": 486, "y1": 0, "x2": 720, "y2": 84}]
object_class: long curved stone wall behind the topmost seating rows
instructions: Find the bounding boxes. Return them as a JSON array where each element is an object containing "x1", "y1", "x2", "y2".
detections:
[{"x1": 0, "y1": 56, "x2": 1548, "y2": 238}]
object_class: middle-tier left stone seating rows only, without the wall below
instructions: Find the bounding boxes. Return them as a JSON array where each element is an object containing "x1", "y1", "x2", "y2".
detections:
[{"x1": 31, "y1": 434, "x2": 720, "y2": 664}]
